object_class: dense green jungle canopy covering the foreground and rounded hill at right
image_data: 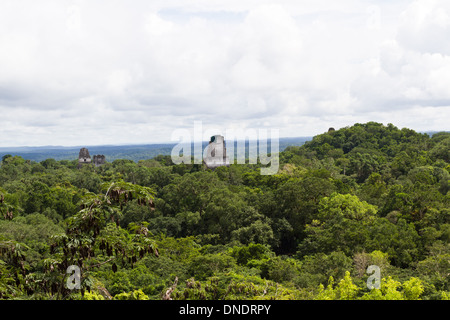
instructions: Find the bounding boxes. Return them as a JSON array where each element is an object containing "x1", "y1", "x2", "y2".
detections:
[{"x1": 0, "y1": 122, "x2": 450, "y2": 300}]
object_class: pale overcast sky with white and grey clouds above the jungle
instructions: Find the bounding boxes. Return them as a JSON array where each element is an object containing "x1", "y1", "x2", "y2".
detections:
[{"x1": 0, "y1": 0, "x2": 450, "y2": 147}]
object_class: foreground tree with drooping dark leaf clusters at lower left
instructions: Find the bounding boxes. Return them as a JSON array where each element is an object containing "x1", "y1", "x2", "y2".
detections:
[{"x1": 33, "y1": 181, "x2": 158, "y2": 299}]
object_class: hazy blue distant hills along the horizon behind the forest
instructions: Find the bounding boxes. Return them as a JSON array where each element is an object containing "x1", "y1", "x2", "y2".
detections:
[{"x1": 0, "y1": 137, "x2": 312, "y2": 162}]
